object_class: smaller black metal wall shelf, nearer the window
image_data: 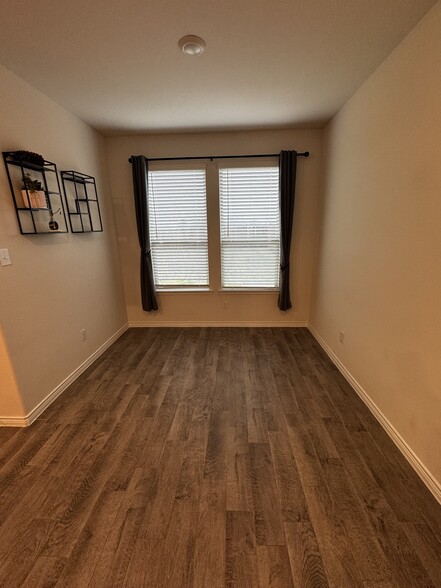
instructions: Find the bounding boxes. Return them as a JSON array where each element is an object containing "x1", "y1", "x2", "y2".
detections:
[{"x1": 61, "y1": 170, "x2": 103, "y2": 233}]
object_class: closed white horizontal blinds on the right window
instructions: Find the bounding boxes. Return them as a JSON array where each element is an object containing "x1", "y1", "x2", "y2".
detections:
[{"x1": 219, "y1": 166, "x2": 280, "y2": 288}]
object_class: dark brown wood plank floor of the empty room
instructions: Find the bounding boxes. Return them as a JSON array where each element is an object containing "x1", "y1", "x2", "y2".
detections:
[{"x1": 0, "y1": 328, "x2": 441, "y2": 588}]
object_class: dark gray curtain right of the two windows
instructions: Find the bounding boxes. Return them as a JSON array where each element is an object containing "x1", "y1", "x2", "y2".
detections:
[{"x1": 278, "y1": 151, "x2": 297, "y2": 310}]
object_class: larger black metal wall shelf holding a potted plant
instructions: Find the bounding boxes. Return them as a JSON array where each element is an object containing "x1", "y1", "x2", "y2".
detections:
[{"x1": 3, "y1": 151, "x2": 68, "y2": 235}]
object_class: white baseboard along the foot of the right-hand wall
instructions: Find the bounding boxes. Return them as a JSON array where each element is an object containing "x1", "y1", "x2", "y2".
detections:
[{"x1": 308, "y1": 324, "x2": 441, "y2": 504}]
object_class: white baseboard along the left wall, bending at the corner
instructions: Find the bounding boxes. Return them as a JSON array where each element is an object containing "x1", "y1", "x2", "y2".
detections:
[{"x1": 0, "y1": 323, "x2": 129, "y2": 427}]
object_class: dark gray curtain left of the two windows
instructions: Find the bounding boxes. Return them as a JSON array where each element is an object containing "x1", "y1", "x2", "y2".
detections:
[{"x1": 130, "y1": 155, "x2": 158, "y2": 311}]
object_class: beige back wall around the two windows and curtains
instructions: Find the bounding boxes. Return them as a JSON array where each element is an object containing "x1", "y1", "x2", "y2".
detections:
[{"x1": 107, "y1": 131, "x2": 321, "y2": 325}]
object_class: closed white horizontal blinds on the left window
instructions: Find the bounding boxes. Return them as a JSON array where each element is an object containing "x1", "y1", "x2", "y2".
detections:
[{"x1": 148, "y1": 169, "x2": 209, "y2": 288}]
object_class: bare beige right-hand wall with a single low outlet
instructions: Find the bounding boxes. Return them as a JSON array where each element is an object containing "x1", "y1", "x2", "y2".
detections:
[{"x1": 311, "y1": 3, "x2": 441, "y2": 480}]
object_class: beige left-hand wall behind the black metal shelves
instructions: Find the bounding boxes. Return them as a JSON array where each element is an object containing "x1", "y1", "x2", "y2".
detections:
[{"x1": 0, "y1": 66, "x2": 126, "y2": 418}]
